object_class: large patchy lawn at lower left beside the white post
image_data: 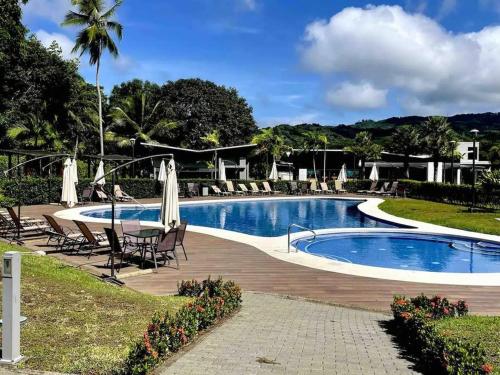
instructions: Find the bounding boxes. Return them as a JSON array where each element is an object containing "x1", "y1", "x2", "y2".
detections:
[{"x1": 0, "y1": 244, "x2": 188, "y2": 374}]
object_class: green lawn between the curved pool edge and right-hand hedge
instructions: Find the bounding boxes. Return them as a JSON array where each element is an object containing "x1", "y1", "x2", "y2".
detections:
[{"x1": 379, "y1": 199, "x2": 500, "y2": 235}]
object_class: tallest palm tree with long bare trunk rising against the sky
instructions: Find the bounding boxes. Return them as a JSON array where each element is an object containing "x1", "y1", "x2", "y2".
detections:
[{"x1": 62, "y1": 0, "x2": 123, "y2": 155}]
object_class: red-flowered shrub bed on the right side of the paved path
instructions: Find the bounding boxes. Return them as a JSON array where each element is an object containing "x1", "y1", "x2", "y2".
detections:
[{"x1": 391, "y1": 295, "x2": 493, "y2": 374}]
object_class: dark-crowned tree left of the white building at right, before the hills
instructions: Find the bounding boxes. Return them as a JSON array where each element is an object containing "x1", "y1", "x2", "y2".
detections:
[{"x1": 419, "y1": 116, "x2": 455, "y2": 181}]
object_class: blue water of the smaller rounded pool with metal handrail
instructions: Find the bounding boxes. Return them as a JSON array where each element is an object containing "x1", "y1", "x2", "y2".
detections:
[{"x1": 294, "y1": 232, "x2": 500, "y2": 273}]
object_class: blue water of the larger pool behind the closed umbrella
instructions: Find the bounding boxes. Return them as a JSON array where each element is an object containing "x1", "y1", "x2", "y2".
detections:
[{"x1": 82, "y1": 199, "x2": 395, "y2": 237}]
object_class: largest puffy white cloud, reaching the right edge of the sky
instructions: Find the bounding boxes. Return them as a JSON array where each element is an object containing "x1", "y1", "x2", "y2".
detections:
[{"x1": 301, "y1": 5, "x2": 500, "y2": 114}]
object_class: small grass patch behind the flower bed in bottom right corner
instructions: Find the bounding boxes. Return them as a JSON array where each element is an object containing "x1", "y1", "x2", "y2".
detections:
[{"x1": 435, "y1": 316, "x2": 500, "y2": 374}]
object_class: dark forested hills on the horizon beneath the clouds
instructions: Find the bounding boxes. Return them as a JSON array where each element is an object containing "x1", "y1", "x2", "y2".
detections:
[{"x1": 276, "y1": 113, "x2": 500, "y2": 150}]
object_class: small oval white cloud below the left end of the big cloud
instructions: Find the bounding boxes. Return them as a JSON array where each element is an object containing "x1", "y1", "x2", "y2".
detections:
[{"x1": 326, "y1": 82, "x2": 387, "y2": 110}]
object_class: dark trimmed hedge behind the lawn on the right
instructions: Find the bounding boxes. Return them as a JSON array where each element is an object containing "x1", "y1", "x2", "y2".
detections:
[{"x1": 400, "y1": 180, "x2": 500, "y2": 208}]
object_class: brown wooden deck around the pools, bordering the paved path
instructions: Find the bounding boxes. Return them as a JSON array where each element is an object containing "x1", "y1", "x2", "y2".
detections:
[{"x1": 13, "y1": 200, "x2": 500, "y2": 315}]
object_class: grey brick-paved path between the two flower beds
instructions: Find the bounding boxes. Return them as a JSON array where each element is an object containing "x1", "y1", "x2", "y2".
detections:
[{"x1": 159, "y1": 293, "x2": 416, "y2": 375}]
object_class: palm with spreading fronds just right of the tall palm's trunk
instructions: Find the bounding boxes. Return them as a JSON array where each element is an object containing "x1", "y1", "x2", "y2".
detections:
[{"x1": 105, "y1": 90, "x2": 177, "y2": 147}]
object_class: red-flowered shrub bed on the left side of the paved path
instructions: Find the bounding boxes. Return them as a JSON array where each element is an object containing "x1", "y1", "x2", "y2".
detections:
[{"x1": 125, "y1": 278, "x2": 241, "y2": 374}]
